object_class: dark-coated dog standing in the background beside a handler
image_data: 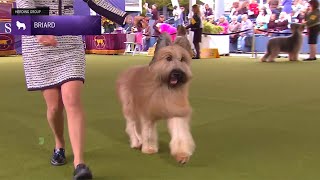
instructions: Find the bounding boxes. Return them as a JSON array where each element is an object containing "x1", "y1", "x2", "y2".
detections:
[{"x1": 261, "y1": 23, "x2": 305, "y2": 62}]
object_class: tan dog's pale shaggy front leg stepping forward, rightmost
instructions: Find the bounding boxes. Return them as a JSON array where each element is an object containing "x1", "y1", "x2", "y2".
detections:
[{"x1": 168, "y1": 117, "x2": 195, "y2": 164}]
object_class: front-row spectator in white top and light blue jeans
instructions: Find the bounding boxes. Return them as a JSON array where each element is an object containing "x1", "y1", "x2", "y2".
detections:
[{"x1": 237, "y1": 14, "x2": 253, "y2": 51}]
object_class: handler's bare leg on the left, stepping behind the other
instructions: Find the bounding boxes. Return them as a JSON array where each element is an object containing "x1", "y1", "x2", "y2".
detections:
[{"x1": 42, "y1": 88, "x2": 65, "y2": 149}]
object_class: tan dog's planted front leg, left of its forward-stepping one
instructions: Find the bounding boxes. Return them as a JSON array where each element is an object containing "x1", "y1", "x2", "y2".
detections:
[{"x1": 141, "y1": 118, "x2": 158, "y2": 154}]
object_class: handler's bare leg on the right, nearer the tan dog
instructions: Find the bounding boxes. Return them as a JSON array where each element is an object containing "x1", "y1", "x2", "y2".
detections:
[{"x1": 61, "y1": 81, "x2": 85, "y2": 167}]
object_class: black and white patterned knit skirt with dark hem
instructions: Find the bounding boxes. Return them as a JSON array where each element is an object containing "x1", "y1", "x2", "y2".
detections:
[{"x1": 22, "y1": 36, "x2": 86, "y2": 91}]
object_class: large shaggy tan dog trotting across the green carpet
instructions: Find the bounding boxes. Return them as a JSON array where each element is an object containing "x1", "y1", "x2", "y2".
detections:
[{"x1": 116, "y1": 33, "x2": 195, "y2": 164}]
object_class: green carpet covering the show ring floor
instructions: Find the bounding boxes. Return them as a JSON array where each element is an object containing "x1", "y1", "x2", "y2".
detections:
[{"x1": 0, "y1": 55, "x2": 320, "y2": 180}]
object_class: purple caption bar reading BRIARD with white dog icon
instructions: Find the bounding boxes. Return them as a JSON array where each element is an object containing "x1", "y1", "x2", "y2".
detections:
[{"x1": 11, "y1": 16, "x2": 101, "y2": 36}]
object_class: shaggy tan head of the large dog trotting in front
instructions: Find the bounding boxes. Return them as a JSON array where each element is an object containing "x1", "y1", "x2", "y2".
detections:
[{"x1": 149, "y1": 33, "x2": 192, "y2": 88}]
